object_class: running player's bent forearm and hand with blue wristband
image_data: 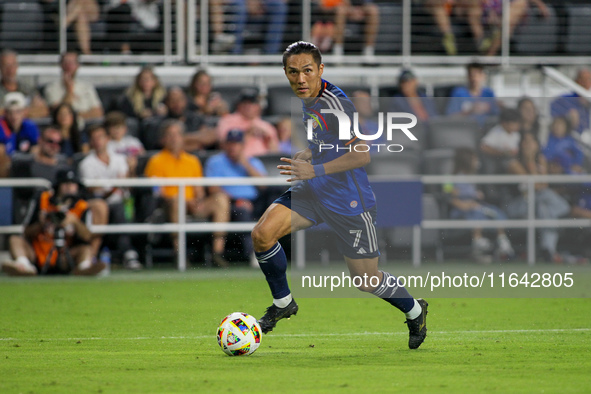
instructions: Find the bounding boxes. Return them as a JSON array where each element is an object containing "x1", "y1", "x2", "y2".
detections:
[{"x1": 277, "y1": 141, "x2": 371, "y2": 182}]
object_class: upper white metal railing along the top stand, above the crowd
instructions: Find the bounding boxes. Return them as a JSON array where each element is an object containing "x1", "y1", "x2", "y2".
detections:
[{"x1": 3, "y1": 0, "x2": 589, "y2": 66}]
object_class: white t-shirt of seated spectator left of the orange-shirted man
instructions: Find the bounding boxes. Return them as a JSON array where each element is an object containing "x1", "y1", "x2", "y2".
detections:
[{"x1": 79, "y1": 151, "x2": 129, "y2": 204}]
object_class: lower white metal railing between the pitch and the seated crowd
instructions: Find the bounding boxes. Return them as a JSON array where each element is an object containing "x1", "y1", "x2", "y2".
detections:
[{"x1": 0, "y1": 175, "x2": 591, "y2": 271}]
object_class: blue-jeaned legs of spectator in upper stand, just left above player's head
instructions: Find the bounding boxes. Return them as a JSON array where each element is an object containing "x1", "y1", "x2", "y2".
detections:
[{"x1": 226, "y1": 0, "x2": 287, "y2": 54}]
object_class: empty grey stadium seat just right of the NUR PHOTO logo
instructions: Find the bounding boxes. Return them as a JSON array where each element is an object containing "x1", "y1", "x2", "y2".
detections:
[{"x1": 429, "y1": 116, "x2": 481, "y2": 149}]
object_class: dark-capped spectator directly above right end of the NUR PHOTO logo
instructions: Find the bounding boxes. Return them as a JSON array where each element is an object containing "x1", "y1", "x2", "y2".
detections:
[{"x1": 392, "y1": 70, "x2": 437, "y2": 121}]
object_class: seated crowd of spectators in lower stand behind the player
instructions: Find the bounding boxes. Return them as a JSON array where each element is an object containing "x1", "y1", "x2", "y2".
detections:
[{"x1": 0, "y1": 50, "x2": 591, "y2": 269}]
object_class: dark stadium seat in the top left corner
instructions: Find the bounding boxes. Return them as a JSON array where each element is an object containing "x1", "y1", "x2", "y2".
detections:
[{"x1": 0, "y1": 1, "x2": 44, "y2": 52}]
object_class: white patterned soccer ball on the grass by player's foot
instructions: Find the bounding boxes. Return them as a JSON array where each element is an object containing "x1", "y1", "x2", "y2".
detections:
[{"x1": 217, "y1": 312, "x2": 261, "y2": 356}]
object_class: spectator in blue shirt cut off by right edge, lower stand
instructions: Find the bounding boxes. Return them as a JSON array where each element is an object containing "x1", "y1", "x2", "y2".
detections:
[{"x1": 550, "y1": 68, "x2": 591, "y2": 138}]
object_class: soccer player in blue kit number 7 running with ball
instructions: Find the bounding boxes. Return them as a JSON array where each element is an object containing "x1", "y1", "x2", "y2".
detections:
[{"x1": 252, "y1": 41, "x2": 428, "y2": 349}]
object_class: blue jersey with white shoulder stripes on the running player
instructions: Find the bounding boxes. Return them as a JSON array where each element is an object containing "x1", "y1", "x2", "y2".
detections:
[{"x1": 303, "y1": 79, "x2": 376, "y2": 216}]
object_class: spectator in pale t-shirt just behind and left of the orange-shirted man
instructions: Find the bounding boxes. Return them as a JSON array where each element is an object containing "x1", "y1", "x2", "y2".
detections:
[{"x1": 105, "y1": 111, "x2": 145, "y2": 176}]
